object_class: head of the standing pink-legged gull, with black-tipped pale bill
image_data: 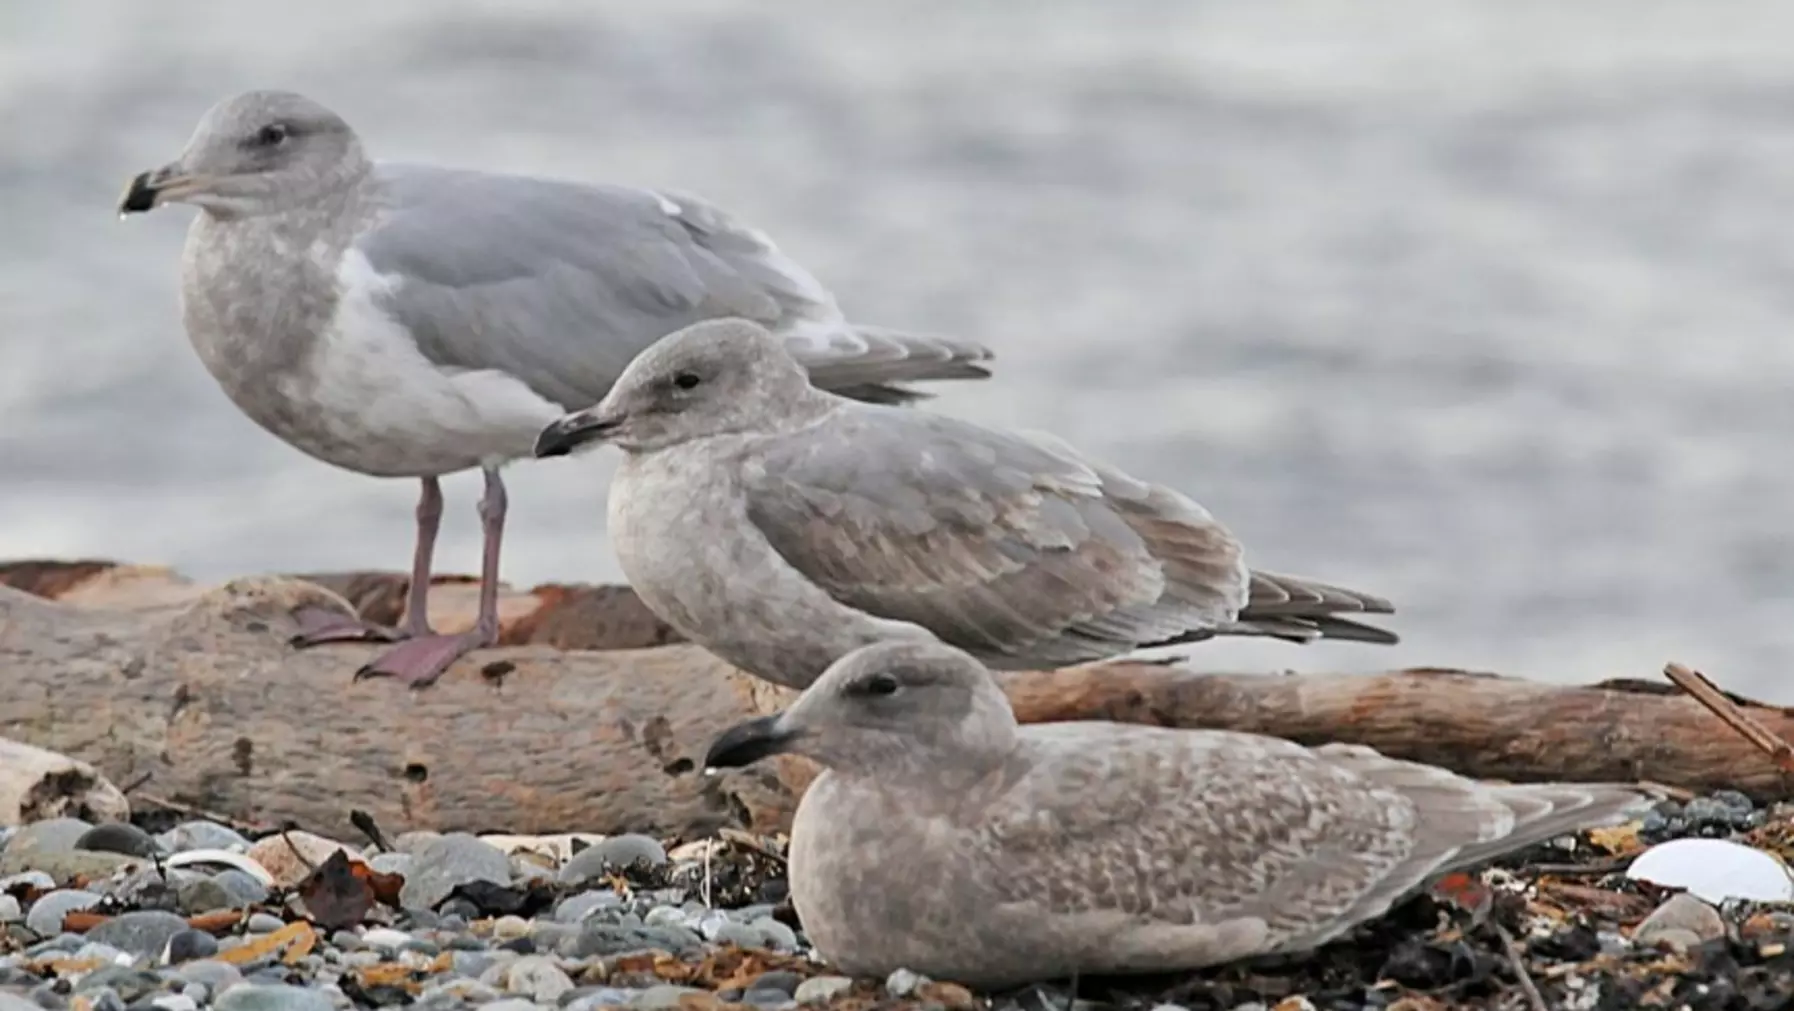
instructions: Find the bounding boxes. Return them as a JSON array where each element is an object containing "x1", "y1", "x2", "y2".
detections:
[{"x1": 118, "y1": 91, "x2": 368, "y2": 217}]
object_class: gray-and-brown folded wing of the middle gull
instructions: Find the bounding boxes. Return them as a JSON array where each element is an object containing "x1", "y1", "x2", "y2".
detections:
[{"x1": 745, "y1": 405, "x2": 1247, "y2": 669}]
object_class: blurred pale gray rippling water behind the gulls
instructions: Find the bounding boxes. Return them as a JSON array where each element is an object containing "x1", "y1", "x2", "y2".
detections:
[{"x1": 0, "y1": 0, "x2": 1794, "y2": 701}]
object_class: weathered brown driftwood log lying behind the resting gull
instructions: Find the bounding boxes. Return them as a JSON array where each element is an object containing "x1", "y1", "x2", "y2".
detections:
[{"x1": 0, "y1": 563, "x2": 1794, "y2": 837}]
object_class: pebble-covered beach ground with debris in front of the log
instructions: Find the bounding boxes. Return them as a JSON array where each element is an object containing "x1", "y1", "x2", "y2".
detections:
[{"x1": 0, "y1": 794, "x2": 1794, "y2": 1011}]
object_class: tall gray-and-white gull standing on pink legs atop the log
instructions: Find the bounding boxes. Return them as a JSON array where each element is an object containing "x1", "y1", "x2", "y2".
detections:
[{"x1": 120, "y1": 91, "x2": 988, "y2": 685}]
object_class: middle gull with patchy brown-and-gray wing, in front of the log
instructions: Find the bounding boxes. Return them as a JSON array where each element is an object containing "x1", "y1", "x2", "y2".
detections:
[{"x1": 536, "y1": 319, "x2": 1396, "y2": 688}]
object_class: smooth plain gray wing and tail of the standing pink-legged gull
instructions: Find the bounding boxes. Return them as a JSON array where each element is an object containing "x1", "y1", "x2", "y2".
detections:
[{"x1": 353, "y1": 163, "x2": 988, "y2": 409}]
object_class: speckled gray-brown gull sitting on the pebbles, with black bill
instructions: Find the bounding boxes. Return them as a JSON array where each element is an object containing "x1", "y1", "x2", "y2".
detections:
[{"x1": 705, "y1": 640, "x2": 1652, "y2": 989}]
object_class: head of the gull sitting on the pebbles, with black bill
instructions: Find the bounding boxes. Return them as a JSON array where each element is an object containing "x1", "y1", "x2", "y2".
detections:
[{"x1": 705, "y1": 638, "x2": 1015, "y2": 776}]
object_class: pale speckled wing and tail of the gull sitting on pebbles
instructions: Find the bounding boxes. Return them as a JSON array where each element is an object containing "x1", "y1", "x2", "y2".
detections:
[{"x1": 987, "y1": 722, "x2": 1650, "y2": 952}]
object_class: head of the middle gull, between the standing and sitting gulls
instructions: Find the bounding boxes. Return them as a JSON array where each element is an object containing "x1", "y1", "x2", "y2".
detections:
[{"x1": 536, "y1": 317, "x2": 818, "y2": 457}]
